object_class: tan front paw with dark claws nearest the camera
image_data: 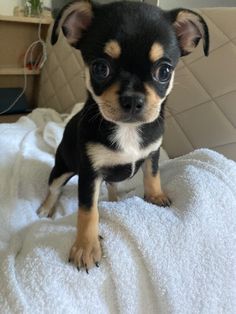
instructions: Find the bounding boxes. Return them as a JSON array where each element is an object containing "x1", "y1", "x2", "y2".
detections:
[{"x1": 69, "y1": 235, "x2": 102, "y2": 273}]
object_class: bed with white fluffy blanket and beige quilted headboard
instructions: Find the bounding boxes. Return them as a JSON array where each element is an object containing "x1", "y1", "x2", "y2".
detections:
[{"x1": 0, "y1": 8, "x2": 236, "y2": 314}]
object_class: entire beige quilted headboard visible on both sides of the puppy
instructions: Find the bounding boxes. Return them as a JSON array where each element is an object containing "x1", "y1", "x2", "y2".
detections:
[{"x1": 39, "y1": 8, "x2": 236, "y2": 160}]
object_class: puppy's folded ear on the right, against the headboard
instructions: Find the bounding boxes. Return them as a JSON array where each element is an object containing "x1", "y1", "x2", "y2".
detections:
[{"x1": 169, "y1": 9, "x2": 209, "y2": 56}]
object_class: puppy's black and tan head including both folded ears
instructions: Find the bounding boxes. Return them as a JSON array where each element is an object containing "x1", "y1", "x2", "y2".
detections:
[{"x1": 52, "y1": 0, "x2": 209, "y2": 124}]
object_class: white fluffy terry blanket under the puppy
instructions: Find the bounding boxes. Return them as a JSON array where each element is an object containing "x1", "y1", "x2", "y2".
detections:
[{"x1": 0, "y1": 109, "x2": 236, "y2": 314}]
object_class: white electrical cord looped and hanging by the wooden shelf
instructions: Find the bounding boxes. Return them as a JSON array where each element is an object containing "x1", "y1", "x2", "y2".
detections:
[{"x1": 0, "y1": 17, "x2": 47, "y2": 115}]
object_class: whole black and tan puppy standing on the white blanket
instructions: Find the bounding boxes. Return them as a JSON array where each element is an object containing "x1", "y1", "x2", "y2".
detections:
[{"x1": 38, "y1": 1, "x2": 209, "y2": 270}]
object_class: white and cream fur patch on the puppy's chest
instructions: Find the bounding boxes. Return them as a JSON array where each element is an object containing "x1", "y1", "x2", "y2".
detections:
[{"x1": 87, "y1": 125, "x2": 162, "y2": 176}]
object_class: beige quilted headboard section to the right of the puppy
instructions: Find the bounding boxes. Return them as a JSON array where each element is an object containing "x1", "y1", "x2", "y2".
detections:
[{"x1": 163, "y1": 8, "x2": 236, "y2": 160}]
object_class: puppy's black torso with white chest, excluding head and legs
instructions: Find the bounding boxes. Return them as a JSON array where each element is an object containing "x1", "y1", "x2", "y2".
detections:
[{"x1": 58, "y1": 94, "x2": 164, "y2": 177}]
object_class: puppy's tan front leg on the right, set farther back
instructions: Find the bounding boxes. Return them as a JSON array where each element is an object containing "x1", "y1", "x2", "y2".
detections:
[{"x1": 143, "y1": 149, "x2": 171, "y2": 207}]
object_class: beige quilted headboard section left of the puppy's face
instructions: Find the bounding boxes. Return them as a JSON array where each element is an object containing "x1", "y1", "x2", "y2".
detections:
[{"x1": 38, "y1": 24, "x2": 86, "y2": 113}]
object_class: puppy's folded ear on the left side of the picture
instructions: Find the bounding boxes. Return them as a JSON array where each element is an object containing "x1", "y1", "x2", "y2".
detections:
[{"x1": 51, "y1": 0, "x2": 93, "y2": 46}]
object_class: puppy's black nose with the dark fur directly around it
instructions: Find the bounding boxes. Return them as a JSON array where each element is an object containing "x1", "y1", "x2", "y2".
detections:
[{"x1": 119, "y1": 93, "x2": 145, "y2": 120}]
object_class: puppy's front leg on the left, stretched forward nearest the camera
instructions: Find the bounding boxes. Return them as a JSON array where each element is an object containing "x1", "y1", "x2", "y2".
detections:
[{"x1": 69, "y1": 171, "x2": 102, "y2": 272}]
